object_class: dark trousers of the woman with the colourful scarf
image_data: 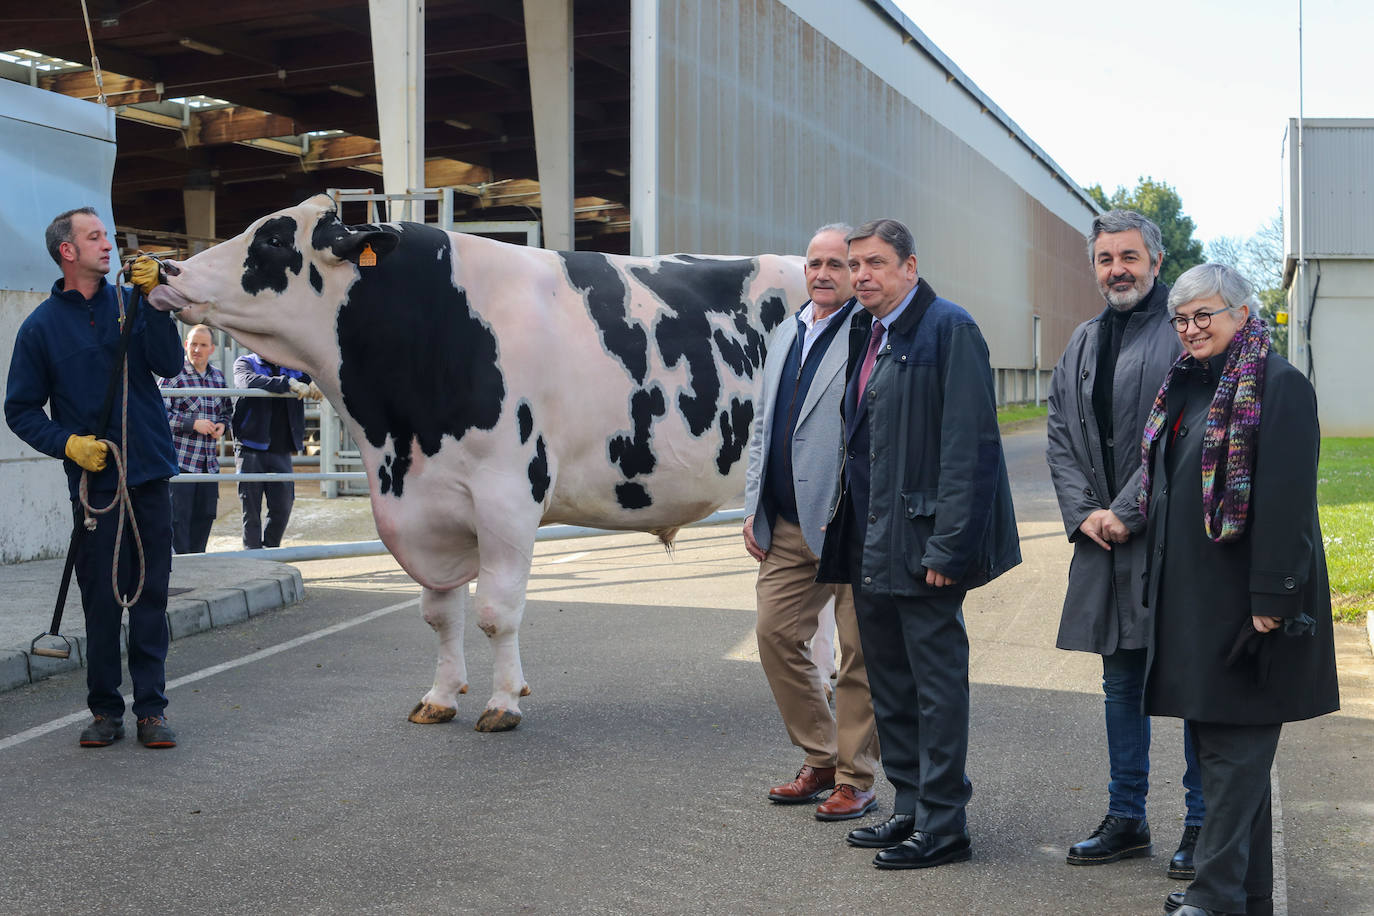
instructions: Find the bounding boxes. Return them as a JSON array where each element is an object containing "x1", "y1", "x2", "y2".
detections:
[{"x1": 1187, "y1": 722, "x2": 1282, "y2": 913}]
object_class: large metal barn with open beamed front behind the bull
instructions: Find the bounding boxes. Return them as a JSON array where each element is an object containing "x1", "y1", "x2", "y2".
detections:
[{"x1": 0, "y1": 0, "x2": 1102, "y2": 559}]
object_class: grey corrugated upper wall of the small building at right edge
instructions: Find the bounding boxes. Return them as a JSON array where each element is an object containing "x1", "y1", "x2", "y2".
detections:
[{"x1": 1287, "y1": 118, "x2": 1374, "y2": 258}]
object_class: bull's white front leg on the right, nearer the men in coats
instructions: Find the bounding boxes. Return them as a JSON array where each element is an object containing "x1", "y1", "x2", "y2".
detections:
[{"x1": 475, "y1": 544, "x2": 529, "y2": 732}]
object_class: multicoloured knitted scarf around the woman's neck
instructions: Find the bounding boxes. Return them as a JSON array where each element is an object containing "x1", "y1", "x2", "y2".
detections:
[{"x1": 1136, "y1": 314, "x2": 1270, "y2": 544}]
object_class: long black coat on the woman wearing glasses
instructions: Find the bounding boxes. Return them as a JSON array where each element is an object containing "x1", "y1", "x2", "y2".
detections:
[{"x1": 1145, "y1": 354, "x2": 1340, "y2": 725}]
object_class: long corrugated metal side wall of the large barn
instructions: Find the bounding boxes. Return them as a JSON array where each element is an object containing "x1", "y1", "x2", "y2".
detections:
[{"x1": 657, "y1": 0, "x2": 1102, "y2": 368}]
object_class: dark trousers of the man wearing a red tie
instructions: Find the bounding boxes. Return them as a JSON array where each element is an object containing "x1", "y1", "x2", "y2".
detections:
[{"x1": 852, "y1": 579, "x2": 973, "y2": 834}]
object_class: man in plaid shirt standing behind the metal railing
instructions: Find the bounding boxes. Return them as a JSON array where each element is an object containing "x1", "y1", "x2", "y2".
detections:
[{"x1": 161, "y1": 324, "x2": 231, "y2": 553}]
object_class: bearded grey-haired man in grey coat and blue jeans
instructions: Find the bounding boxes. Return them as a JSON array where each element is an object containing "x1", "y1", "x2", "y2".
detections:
[{"x1": 1046, "y1": 210, "x2": 1206, "y2": 880}]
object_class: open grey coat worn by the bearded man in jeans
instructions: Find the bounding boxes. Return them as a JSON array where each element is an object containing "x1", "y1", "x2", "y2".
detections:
[{"x1": 1046, "y1": 282, "x2": 1183, "y2": 655}]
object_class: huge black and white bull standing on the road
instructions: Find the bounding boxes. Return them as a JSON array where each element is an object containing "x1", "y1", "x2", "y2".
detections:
[{"x1": 153, "y1": 195, "x2": 805, "y2": 731}]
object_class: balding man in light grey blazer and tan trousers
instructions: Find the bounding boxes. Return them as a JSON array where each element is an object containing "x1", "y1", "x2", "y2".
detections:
[{"x1": 745, "y1": 224, "x2": 878, "y2": 820}]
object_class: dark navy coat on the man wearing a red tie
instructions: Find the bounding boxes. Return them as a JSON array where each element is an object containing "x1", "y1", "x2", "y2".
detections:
[{"x1": 816, "y1": 280, "x2": 1021, "y2": 596}]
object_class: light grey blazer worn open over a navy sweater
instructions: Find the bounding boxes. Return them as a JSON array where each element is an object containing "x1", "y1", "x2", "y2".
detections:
[{"x1": 745, "y1": 305, "x2": 860, "y2": 556}]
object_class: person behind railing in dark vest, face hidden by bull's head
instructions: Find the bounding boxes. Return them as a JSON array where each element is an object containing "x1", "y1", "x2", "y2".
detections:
[{"x1": 232, "y1": 353, "x2": 322, "y2": 551}]
